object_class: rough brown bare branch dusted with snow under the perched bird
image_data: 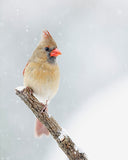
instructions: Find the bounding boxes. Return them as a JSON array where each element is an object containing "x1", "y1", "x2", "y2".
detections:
[{"x1": 16, "y1": 87, "x2": 87, "y2": 160}]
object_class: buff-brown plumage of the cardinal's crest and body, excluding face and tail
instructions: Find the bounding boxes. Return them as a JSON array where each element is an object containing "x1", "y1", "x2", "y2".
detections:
[{"x1": 24, "y1": 31, "x2": 60, "y2": 102}]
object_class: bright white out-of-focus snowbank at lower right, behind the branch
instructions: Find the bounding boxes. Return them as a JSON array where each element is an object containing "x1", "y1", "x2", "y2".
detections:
[{"x1": 49, "y1": 77, "x2": 128, "y2": 160}]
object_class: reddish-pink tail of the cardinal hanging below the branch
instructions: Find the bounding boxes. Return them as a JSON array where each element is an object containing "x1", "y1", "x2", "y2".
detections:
[{"x1": 35, "y1": 119, "x2": 49, "y2": 137}]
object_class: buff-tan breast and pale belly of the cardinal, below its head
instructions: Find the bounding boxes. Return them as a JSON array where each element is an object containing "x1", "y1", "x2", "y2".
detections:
[{"x1": 24, "y1": 62, "x2": 60, "y2": 100}]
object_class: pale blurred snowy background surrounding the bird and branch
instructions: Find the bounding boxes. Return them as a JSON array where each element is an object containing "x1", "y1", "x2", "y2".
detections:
[{"x1": 0, "y1": 0, "x2": 128, "y2": 160}]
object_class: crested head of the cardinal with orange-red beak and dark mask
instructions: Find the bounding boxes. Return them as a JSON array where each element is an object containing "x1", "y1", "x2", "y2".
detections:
[{"x1": 32, "y1": 30, "x2": 61, "y2": 64}]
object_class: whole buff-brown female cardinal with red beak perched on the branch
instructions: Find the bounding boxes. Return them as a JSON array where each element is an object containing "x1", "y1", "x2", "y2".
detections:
[{"x1": 23, "y1": 30, "x2": 61, "y2": 136}]
